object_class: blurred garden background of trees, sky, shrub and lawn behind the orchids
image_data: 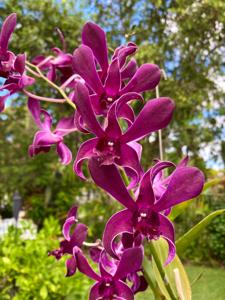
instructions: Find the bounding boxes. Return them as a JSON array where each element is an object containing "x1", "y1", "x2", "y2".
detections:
[{"x1": 0, "y1": 0, "x2": 225, "y2": 300}]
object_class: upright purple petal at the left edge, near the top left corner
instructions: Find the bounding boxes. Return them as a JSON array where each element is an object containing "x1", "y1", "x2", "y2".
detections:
[{"x1": 0, "y1": 13, "x2": 16, "y2": 51}]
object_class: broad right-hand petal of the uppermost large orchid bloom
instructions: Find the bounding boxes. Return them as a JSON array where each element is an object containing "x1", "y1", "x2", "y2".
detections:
[{"x1": 120, "y1": 64, "x2": 161, "y2": 94}]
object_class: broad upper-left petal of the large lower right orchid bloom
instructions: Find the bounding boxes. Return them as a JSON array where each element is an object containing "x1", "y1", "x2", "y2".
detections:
[{"x1": 88, "y1": 159, "x2": 136, "y2": 210}]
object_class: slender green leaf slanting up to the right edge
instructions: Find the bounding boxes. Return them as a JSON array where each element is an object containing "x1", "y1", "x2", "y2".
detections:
[{"x1": 176, "y1": 209, "x2": 225, "y2": 253}]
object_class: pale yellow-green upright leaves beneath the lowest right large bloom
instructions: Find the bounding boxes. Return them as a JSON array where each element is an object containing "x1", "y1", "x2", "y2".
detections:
[{"x1": 150, "y1": 239, "x2": 191, "y2": 300}]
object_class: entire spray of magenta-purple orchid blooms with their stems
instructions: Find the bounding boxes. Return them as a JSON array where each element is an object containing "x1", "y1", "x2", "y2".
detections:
[{"x1": 0, "y1": 14, "x2": 204, "y2": 300}]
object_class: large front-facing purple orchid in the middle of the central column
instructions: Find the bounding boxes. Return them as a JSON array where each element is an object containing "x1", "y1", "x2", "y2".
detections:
[{"x1": 74, "y1": 83, "x2": 174, "y2": 188}]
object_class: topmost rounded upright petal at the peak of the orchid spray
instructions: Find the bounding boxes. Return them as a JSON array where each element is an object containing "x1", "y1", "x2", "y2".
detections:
[{"x1": 82, "y1": 22, "x2": 108, "y2": 72}]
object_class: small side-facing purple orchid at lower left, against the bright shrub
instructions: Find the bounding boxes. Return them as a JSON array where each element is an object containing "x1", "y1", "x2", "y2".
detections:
[{"x1": 48, "y1": 206, "x2": 88, "y2": 277}]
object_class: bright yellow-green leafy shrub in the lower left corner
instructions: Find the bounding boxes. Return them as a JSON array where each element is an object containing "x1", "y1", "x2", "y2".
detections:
[{"x1": 0, "y1": 217, "x2": 90, "y2": 300}]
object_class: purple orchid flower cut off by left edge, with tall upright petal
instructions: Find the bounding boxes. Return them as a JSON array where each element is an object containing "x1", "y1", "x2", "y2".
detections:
[{"x1": 0, "y1": 13, "x2": 16, "y2": 78}]
